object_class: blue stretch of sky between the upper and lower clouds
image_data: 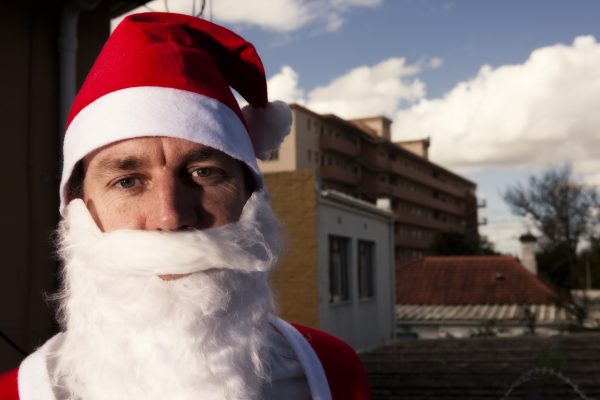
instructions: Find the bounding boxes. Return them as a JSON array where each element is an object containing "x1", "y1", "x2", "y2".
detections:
[{"x1": 241, "y1": 0, "x2": 600, "y2": 97}]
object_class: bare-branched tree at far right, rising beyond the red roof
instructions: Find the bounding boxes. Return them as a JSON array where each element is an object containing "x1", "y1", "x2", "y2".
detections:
[{"x1": 502, "y1": 165, "x2": 600, "y2": 289}]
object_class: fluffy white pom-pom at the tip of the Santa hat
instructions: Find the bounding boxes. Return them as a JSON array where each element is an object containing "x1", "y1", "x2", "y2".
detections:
[{"x1": 242, "y1": 101, "x2": 292, "y2": 160}]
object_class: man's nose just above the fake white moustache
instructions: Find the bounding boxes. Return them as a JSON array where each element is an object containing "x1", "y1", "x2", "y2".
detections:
[{"x1": 145, "y1": 177, "x2": 199, "y2": 231}]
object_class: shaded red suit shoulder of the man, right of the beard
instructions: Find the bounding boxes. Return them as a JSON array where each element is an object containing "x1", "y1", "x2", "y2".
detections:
[{"x1": 292, "y1": 324, "x2": 371, "y2": 400}]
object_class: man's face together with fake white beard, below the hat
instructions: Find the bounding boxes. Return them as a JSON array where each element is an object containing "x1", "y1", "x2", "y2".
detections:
[{"x1": 52, "y1": 141, "x2": 274, "y2": 399}]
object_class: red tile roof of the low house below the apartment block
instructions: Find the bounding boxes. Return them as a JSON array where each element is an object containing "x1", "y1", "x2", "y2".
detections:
[{"x1": 396, "y1": 256, "x2": 554, "y2": 305}]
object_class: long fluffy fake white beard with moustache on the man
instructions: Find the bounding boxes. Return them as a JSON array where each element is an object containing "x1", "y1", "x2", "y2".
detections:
[{"x1": 53, "y1": 193, "x2": 282, "y2": 400}]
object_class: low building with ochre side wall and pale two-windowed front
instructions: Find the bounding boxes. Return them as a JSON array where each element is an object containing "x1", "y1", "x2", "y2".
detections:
[{"x1": 265, "y1": 171, "x2": 395, "y2": 350}]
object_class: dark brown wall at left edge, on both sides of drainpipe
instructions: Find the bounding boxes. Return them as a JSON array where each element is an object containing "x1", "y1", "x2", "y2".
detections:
[{"x1": 0, "y1": 0, "x2": 109, "y2": 372}]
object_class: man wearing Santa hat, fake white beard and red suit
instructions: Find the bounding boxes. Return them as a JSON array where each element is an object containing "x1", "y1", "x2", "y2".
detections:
[{"x1": 0, "y1": 13, "x2": 369, "y2": 400}]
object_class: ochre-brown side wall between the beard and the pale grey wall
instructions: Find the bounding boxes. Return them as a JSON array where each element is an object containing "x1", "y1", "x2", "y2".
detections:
[{"x1": 265, "y1": 171, "x2": 319, "y2": 328}]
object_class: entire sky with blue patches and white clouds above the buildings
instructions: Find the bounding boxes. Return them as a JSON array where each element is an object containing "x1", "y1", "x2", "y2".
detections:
[{"x1": 116, "y1": 0, "x2": 600, "y2": 254}]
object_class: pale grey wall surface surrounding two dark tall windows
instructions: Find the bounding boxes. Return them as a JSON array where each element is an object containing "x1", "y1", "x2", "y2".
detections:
[{"x1": 318, "y1": 192, "x2": 395, "y2": 350}]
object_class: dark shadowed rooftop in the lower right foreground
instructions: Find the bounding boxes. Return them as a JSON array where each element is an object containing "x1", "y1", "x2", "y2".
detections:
[{"x1": 360, "y1": 333, "x2": 600, "y2": 400}]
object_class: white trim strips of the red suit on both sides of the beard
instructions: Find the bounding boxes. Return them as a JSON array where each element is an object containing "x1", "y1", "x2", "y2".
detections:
[{"x1": 18, "y1": 315, "x2": 331, "y2": 400}]
